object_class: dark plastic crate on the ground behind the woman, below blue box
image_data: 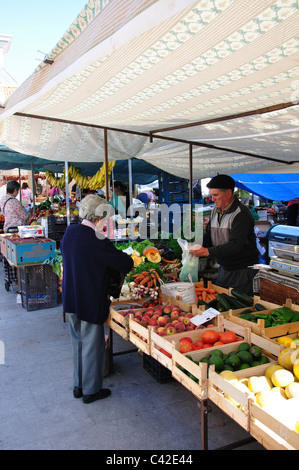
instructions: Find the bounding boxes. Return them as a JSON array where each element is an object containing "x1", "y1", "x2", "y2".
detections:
[{"x1": 18, "y1": 264, "x2": 57, "y2": 312}]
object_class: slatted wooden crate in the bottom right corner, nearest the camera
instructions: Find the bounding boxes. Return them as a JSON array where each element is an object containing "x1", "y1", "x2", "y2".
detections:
[{"x1": 249, "y1": 398, "x2": 299, "y2": 450}]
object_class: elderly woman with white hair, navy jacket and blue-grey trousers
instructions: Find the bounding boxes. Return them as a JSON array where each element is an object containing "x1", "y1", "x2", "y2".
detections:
[{"x1": 60, "y1": 194, "x2": 133, "y2": 403}]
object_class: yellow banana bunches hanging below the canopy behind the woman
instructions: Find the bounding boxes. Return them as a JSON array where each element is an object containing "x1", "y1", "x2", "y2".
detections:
[{"x1": 46, "y1": 162, "x2": 115, "y2": 191}]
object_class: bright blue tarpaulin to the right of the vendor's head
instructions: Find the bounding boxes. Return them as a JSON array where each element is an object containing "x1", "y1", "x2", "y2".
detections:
[{"x1": 231, "y1": 173, "x2": 299, "y2": 201}]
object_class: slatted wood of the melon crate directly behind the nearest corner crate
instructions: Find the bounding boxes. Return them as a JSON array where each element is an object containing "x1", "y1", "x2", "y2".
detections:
[{"x1": 207, "y1": 362, "x2": 275, "y2": 432}]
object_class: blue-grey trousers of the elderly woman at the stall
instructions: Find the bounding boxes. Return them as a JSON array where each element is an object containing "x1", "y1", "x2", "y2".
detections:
[{"x1": 68, "y1": 313, "x2": 105, "y2": 395}]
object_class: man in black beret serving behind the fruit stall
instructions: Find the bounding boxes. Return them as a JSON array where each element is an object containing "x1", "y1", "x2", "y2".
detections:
[{"x1": 190, "y1": 174, "x2": 259, "y2": 295}]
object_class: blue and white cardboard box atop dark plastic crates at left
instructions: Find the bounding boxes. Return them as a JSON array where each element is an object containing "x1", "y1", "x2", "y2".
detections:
[{"x1": 7, "y1": 238, "x2": 56, "y2": 266}]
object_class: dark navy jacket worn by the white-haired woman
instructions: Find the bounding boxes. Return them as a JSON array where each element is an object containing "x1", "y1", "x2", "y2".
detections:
[{"x1": 60, "y1": 224, "x2": 134, "y2": 324}]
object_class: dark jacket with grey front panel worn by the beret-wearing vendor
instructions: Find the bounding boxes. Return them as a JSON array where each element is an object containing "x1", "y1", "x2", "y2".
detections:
[{"x1": 203, "y1": 198, "x2": 259, "y2": 271}]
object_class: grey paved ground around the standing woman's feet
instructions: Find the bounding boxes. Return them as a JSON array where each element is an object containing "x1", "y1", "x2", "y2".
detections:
[{"x1": 0, "y1": 262, "x2": 264, "y2": 451}]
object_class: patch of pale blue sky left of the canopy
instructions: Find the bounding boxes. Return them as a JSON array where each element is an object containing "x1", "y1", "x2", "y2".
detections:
[{"x1": 0, "y1": 0, "x2": 88, "y2": 84}]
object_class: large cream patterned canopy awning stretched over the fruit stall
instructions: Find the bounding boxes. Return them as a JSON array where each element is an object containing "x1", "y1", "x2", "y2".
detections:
[{"x1": 0, "y1": 0, "x2": 299, "y2": 178}]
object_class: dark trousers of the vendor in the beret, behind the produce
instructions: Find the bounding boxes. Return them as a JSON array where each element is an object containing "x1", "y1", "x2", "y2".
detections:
[{"x1": 215, "y1": 266, "x2": 258, "y2": 296}]
